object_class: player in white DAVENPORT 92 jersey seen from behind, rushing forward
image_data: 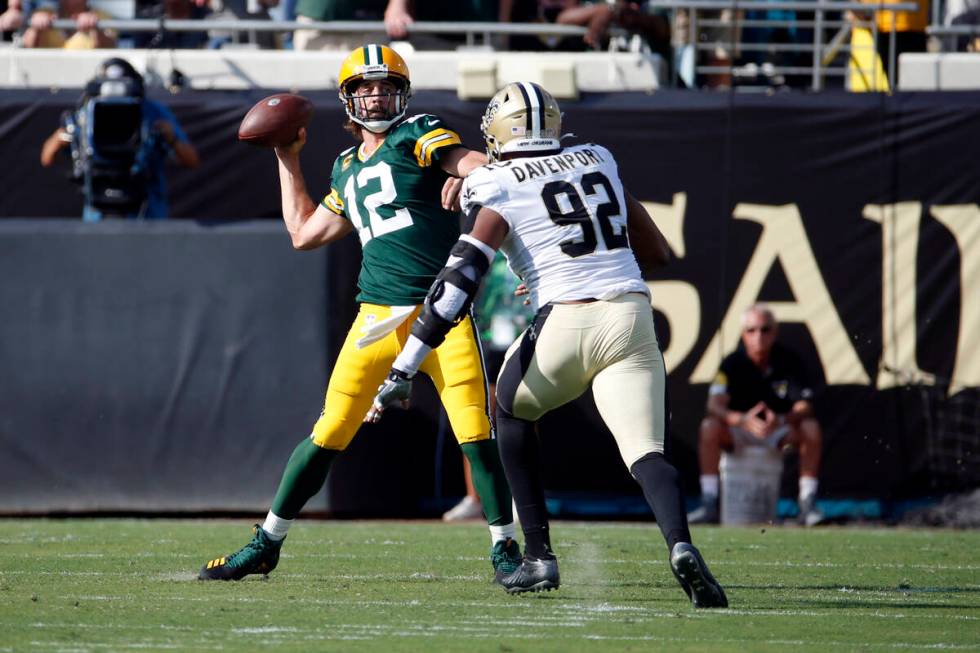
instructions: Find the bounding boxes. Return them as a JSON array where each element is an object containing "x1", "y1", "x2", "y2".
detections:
[{"x1": 365, "y1": 82, "x2": 728, "y2": 608}]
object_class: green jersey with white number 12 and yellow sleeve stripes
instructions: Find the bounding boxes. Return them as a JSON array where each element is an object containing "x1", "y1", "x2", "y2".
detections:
[{"x1": 321, "y1": 114, "x2": 460, "y2": 306}]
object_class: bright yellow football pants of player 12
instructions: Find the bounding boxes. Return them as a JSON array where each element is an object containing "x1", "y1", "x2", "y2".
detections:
[{"x1": 312, "y1": 304, "x2": 490, "y2": 450}]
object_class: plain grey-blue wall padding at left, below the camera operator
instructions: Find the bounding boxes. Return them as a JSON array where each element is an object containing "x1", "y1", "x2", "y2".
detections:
[{"x1": 0, "y1": 220, "x2": 330, "y2": 511}]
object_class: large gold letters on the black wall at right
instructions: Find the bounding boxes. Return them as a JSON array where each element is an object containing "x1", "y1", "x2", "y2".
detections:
[{"x1": 643, "y1": 193, "x2": 980, "y2": 395}]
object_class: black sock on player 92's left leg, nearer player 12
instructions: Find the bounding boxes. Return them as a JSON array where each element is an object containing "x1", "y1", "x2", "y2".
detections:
[{"x1": 497, "y1": 405, "x2": 554, "y2": 558}]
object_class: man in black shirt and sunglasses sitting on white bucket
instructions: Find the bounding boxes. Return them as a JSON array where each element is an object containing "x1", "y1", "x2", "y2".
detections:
[{"x1": 688, "y1": 304, "x2": 823, "y2": 526}]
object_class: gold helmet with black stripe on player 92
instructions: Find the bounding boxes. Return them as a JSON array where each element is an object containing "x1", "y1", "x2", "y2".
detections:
[{"x1": 480, "y1": 82, "x2": 561, "y2": 161}]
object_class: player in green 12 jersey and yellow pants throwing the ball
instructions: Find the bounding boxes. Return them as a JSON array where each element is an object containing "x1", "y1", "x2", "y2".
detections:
[{"x1": 199, "y1": 45, "x2": 521, "y2": 581}]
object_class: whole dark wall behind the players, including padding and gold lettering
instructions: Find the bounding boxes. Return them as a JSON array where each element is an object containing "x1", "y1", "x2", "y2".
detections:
[{"x1": 0, "y1": 89, "x2": 980, "y2": 516}]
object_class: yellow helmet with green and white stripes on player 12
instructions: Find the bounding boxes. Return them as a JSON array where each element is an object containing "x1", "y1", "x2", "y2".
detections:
[{"x1": 337, "y1": 44, "x2": 412, "y2": 133}]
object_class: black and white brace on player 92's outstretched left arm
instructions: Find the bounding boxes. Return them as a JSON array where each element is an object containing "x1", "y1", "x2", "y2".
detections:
[{"x1": 412, "y1": 235, "x2": 493, "y2": 348}]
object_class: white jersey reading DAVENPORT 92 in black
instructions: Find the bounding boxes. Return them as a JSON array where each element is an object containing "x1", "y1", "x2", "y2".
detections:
[{"x1": 462, "y1": 143, "x2": 649, "y2": 311}]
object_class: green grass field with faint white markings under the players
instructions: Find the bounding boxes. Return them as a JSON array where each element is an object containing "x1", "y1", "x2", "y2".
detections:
[{"x1": 0, "y1": 519, "x2": 980, "y2": 653}]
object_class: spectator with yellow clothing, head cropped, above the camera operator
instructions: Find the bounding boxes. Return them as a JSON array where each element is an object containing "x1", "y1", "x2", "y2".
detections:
[{"x1": 23, "y1": 0, "x2": 116, "y2": 50}]
